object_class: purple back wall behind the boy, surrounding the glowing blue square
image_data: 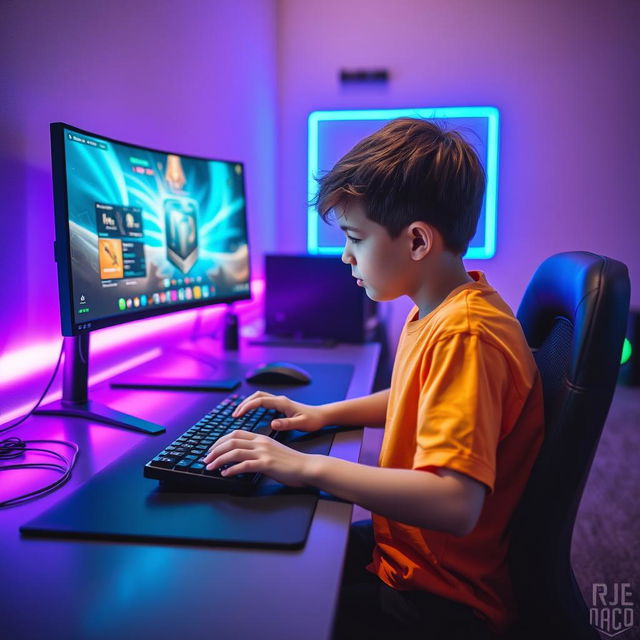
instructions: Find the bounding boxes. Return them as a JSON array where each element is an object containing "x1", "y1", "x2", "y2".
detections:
[{"x1": 278, "y1": 0, "x2": 640, "y2": 344}]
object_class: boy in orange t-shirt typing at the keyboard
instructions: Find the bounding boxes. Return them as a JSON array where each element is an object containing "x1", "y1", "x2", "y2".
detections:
[{"x1": 206, "y1": 118, "x2": 543, "y2": 639}]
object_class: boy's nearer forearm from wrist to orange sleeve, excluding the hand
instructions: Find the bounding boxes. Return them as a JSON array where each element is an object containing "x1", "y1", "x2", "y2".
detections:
[{"x1": 304, "y1": 455, "x2": 486, "y2": 536}]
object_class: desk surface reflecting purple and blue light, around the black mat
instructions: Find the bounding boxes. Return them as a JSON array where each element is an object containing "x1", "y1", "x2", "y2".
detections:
[{"x1": 0, "y1": 343, "x2": 380, "y2": 640}]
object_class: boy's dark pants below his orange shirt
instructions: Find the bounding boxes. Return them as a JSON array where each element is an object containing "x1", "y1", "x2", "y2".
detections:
[{"x1": 333, "y1": 520, "x2": 491, "y2": 640}]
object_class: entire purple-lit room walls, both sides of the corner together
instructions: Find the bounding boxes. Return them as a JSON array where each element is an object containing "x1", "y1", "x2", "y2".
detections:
[{"x1": 0, "y1": 0, "x2": 640, "y2": 412}]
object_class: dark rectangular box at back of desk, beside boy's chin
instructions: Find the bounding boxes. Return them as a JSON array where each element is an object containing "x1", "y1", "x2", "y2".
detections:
[{"x1": 265, "y1": 254, "x2": 378, "y2": 343}]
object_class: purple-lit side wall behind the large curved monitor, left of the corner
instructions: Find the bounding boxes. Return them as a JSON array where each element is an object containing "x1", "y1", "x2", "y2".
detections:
[{"x1": 0, "y1": 0, "x2": 276, "y2": 413}]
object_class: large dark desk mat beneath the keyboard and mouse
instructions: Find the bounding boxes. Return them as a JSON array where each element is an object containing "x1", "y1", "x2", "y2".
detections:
[{"x1": 20, "y1": 363, "x2": 353, "y2": 549}]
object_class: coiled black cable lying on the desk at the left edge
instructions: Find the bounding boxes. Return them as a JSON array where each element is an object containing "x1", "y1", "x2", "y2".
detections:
[{"x1": 0, "y1": 437, "x2": 80, "y2": 508}]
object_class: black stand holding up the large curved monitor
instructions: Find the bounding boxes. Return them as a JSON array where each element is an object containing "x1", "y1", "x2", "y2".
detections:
[{"x1": 34, "y1": 333, "x2": 166, "y2": 435}]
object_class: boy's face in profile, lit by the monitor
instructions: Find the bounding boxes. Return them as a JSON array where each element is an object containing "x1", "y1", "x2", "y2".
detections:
[{"x1": 336, "y1": 202, "x2": 415, "y2": 302}]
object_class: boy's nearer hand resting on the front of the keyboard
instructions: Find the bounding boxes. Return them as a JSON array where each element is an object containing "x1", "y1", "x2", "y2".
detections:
[{"x1": 204, "y1": 430, "x2": 314, "y2": 487}]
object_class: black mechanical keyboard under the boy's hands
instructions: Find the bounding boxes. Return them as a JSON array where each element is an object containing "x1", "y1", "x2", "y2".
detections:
[{"x1": 144, "y1": 393, "x2": 284, "y2": 493}]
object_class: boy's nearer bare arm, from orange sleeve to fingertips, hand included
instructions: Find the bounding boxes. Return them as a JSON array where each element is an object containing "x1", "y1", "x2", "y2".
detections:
[{"x1": 204, "y1": 412, "x2": 486, "y2": 536}]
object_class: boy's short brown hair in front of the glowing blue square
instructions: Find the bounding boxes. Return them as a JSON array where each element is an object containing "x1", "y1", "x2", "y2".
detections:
[{"x1": 313, "y1": 118, "x2": 486, "y2": 255}]
